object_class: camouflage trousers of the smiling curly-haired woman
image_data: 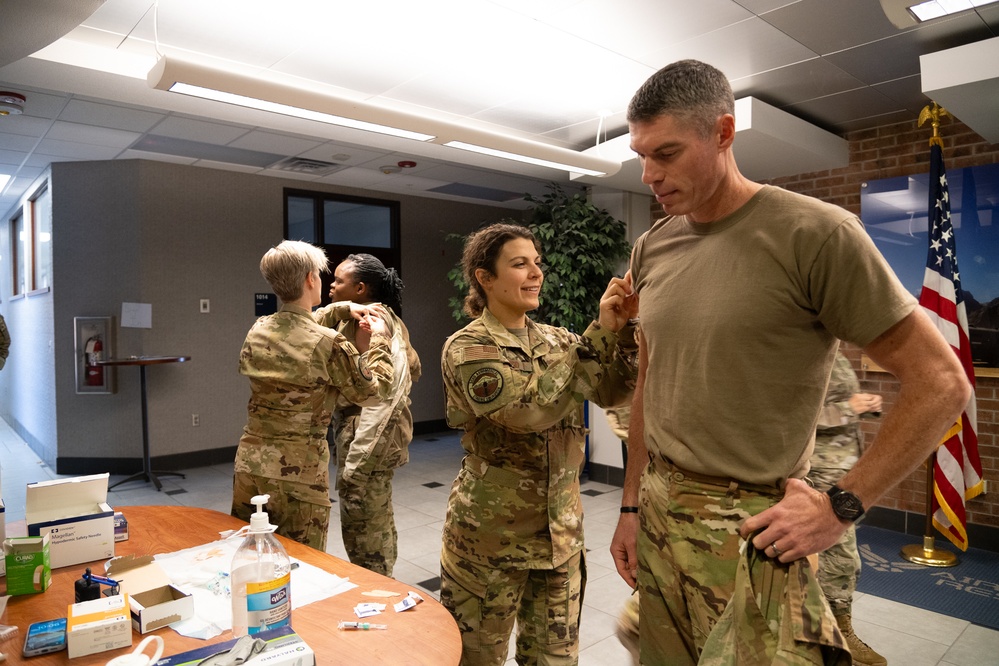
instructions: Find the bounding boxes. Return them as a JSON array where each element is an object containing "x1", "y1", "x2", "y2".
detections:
[{"x1": 441, "y1": 548, "x2": 586, "y2": 666}]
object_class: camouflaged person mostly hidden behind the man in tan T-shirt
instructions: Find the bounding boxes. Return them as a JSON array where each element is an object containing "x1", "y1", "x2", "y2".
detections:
[{"x1": 808, "y1": 351, "x2": 888, "y2": 666}]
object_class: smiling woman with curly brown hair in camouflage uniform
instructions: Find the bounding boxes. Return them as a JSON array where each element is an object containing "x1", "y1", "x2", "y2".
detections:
[{"x1": 441, "y1": 224, "x2": 636, "y2": 666}]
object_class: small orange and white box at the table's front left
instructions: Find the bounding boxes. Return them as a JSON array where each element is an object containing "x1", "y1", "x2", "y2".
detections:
[{"x1": 66, "y1": 593, "x2": 132, "y2": 659}]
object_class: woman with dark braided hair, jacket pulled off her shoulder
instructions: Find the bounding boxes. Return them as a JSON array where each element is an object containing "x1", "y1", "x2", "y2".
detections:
[{"x1": 320, "y1": 253, "x2": 421, "y2": 576}]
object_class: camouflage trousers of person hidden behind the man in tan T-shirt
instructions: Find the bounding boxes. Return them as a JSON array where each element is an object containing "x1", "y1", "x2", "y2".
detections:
[{"x1": 808, "y1": 435, "x2": 861, "y2": 616}]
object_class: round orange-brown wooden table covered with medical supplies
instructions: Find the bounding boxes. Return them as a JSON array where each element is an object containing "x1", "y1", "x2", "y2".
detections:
[{"x1": 0, "y1": 506, "x2": 461, "y2": 666}]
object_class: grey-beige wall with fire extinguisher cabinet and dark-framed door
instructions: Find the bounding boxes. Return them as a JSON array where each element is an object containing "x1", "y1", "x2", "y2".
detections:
[{"x1": 0, "y1": 160, "x2": 519, "y2": 464}]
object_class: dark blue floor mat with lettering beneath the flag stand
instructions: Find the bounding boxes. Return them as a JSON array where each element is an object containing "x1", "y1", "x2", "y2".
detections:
[{"x1": 857, "y1": 525, "x2": 999, "y2": 629}]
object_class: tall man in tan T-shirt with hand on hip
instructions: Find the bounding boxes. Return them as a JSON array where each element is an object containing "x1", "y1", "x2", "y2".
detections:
[{"x1": 611, "y1": 60, "x2": 971, "y2": 666}]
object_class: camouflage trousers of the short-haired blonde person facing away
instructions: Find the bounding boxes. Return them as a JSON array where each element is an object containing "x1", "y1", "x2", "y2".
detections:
[{"x1": 231, "y1": 472, "x2": 333, "y2": 552}]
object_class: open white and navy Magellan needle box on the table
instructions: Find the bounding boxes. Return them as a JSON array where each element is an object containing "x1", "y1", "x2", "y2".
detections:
[{"x1": 24, "y1": 473, "x2": 114, "y2": 569}]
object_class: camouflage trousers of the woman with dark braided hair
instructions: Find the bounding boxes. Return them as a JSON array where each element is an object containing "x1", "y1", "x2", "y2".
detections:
[{"x1": 336, "y1": 469, "x2": 399, "y2": 577}]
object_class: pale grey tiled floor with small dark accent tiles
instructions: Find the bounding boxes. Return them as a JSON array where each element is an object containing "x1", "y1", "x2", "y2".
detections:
[{"x1": 0, "y1": 420, "x2": 999, "y2": 666}]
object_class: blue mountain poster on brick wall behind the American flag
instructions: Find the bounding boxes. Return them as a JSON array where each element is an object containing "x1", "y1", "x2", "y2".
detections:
[{"x1": 860, "y1": 164, "x2": 999, "y2": 377}]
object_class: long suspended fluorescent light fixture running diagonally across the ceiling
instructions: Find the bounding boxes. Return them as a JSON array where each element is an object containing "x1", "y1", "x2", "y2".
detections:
[{"x1": 147, "y1": 56, "x2": 621, "y2": 176}]
